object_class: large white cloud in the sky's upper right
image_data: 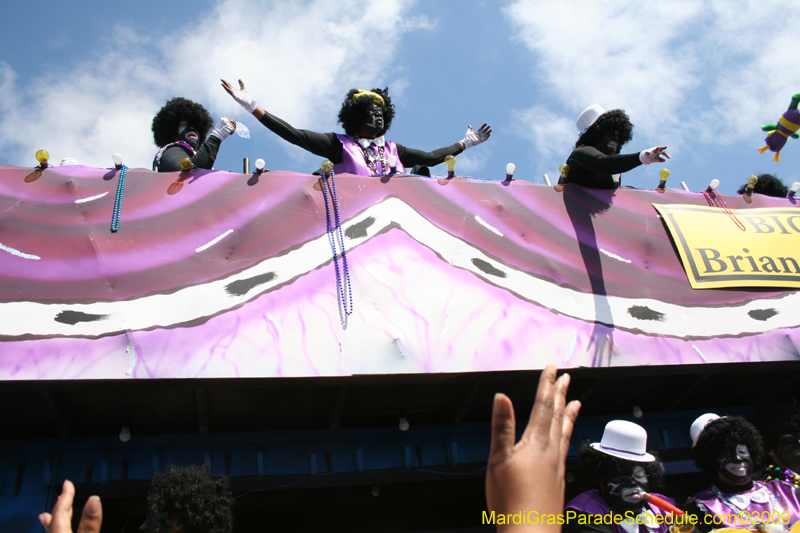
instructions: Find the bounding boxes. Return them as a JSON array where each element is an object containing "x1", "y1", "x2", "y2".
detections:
[{"x1": 505, "y1": 0, "x2": 800, "y2": 164}]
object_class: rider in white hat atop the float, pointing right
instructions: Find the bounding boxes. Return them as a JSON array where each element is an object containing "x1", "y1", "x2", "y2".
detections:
[{"x1": 567, "y1": 104, "x2": 670, "y2": 189}]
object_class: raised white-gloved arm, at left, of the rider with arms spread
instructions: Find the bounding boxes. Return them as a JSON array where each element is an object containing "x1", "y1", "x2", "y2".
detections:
[{"x1": 221, "y1": 80, "x2": 342, "y2": 163}]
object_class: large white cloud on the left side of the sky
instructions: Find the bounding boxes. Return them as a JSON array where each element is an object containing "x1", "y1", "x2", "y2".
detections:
[{"x1": 0, "y1": 0, "x2": 430, "y2": 167}]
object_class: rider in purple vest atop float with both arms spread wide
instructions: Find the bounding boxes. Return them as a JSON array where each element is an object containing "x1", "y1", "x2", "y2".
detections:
[{"x1": 222, "y1": 80, "x2": 492, "y2": 176}]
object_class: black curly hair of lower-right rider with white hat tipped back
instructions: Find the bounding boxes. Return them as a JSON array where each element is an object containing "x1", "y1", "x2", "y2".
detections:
[{"x1": 692, "y1": 416, "x2": 764, "y2": 480}]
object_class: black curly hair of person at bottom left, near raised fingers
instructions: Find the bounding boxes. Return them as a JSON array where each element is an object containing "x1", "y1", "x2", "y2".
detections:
[{"x1": 147, "y1": 465, "x2": 233, "y2": 533}]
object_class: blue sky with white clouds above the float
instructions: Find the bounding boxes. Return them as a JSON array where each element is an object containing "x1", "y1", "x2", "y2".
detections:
[{"x1": 0, "y1": 0, "x2": 800, "y2": 194}]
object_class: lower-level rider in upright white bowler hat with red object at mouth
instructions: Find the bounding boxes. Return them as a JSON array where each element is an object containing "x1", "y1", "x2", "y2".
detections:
[{"x1": 563, "y1": 420, "x2": 675, "y2": 533}]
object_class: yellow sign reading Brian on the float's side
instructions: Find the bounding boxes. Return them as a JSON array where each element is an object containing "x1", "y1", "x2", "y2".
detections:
[{"x1": 653, "y1": 204, "x2": 800, "y2": 289}]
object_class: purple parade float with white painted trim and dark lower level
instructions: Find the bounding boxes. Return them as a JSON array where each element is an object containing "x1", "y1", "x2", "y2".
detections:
[{"x1": 0, "y1": 153, "x2": 800, "y2": 531}]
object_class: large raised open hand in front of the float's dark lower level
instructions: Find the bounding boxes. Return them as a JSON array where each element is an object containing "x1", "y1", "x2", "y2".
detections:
[{"x1": 486, "y1": 365, "x2": 581, "y2": 533}]
